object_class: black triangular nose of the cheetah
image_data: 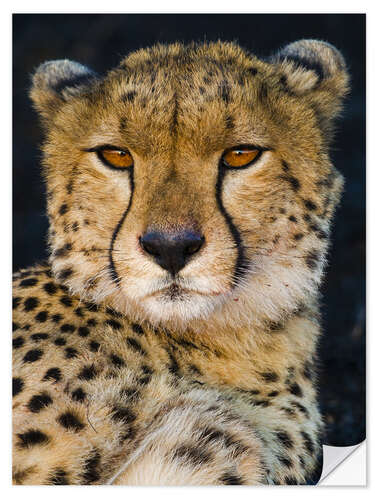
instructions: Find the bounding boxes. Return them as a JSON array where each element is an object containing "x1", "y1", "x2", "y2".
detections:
[{"x1": 139, "y1": 231, "x2": 204, "y2": 275}]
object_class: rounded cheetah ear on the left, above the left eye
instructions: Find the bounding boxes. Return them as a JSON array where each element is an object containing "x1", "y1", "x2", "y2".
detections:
[{"x1": 30, "y1": 59, "x2": 96, "y2": 118}]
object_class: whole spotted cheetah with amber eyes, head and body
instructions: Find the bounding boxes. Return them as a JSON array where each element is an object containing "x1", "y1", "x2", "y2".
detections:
[{"x1": 13, "y1": 40, "x2": 349, "y2": 485}]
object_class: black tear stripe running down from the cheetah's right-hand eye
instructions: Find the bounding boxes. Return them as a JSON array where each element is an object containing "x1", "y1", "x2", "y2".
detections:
[{"x1": 215, "y1": 162, "x2": 249, "y2": 288}]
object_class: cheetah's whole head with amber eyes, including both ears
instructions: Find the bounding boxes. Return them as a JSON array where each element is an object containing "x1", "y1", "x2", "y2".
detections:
[{"x1": 31, "y1": 41, "x2": 347, "y2": 325}]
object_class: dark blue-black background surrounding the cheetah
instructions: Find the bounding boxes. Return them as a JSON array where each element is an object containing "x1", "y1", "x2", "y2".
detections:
[{"x1": 13, "y1": 14, "x2": 365, "y2": 446}]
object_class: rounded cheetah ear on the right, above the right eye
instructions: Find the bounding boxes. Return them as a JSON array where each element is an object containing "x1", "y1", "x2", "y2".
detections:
[{"x1": 271, "y1": 40, "x2": 349, "y2": 137}]
